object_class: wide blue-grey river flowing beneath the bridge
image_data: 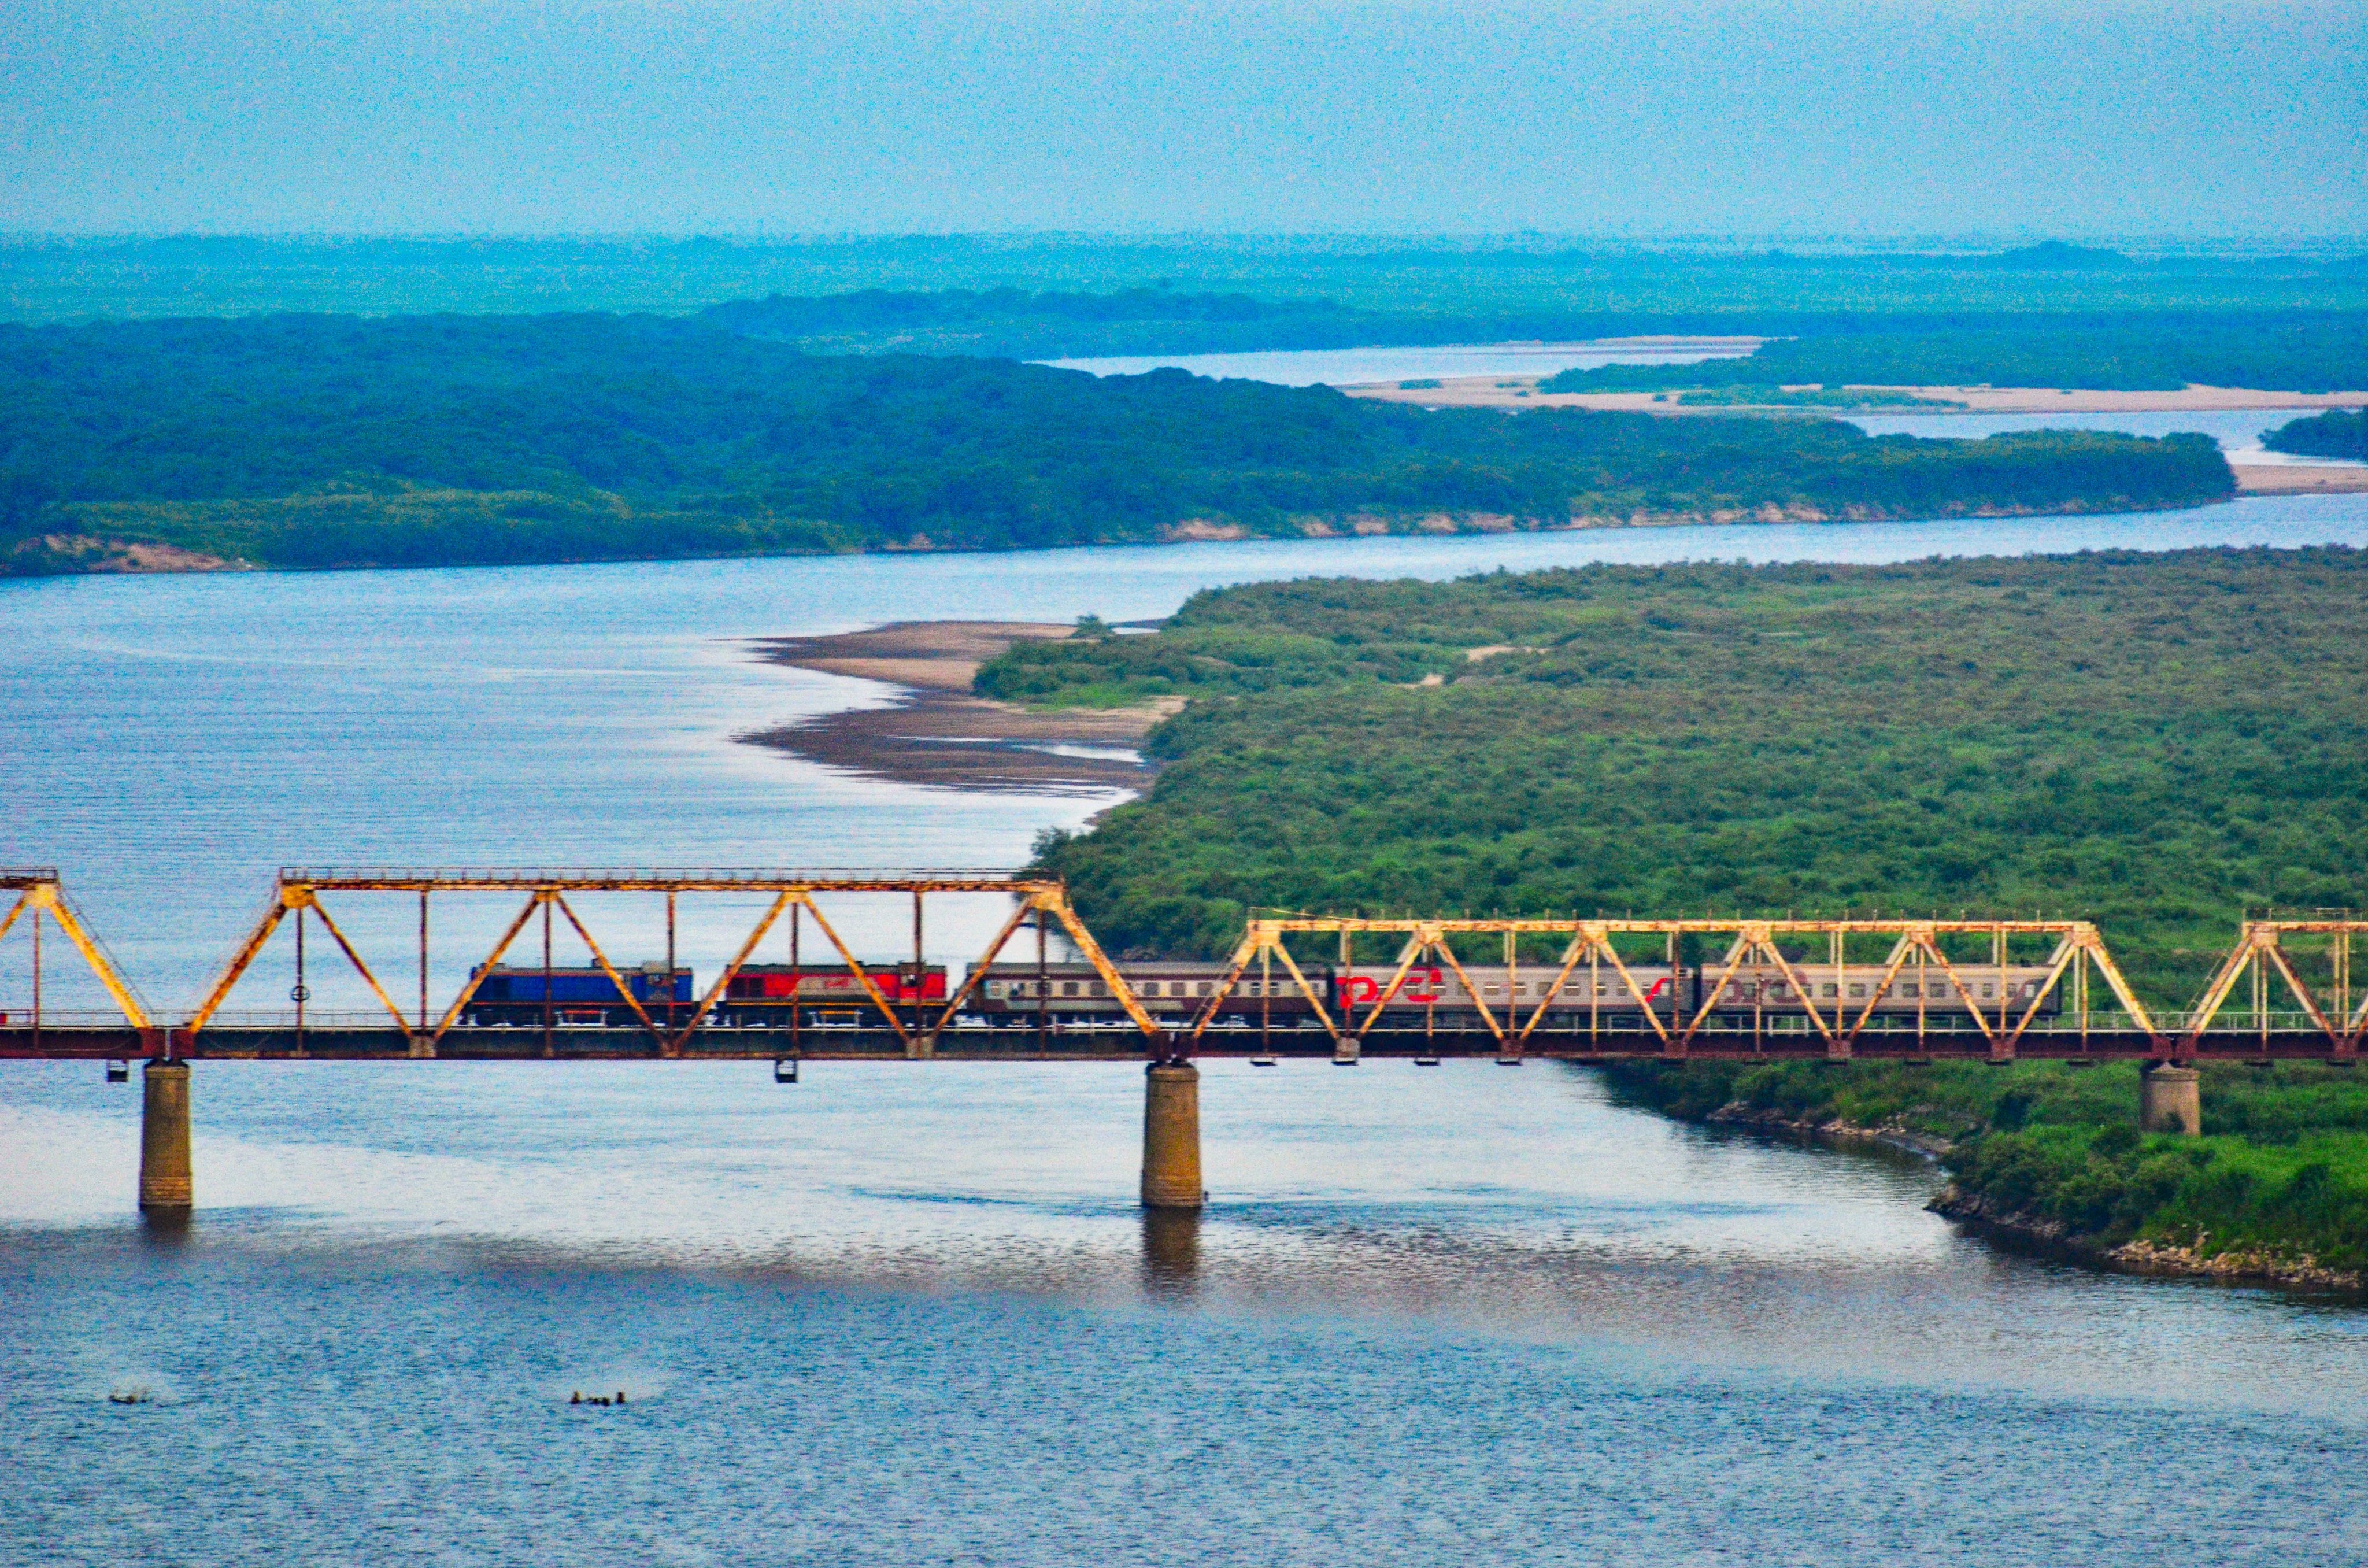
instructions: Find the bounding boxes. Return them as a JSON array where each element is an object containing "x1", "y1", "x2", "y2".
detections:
[{"x1": 0, "y1": 497, "x2": 2368, "y2": 1563}]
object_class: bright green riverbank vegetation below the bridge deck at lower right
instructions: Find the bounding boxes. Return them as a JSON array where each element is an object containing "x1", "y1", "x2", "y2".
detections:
[{"x1": 1608, "y1": 1061, "x2": 2368, "y2": 1272}]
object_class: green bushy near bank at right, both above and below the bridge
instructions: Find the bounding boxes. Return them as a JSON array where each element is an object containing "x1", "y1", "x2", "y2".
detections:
[{"x1": 978, "y1": 549, "x2": 2368, "y2": 1267}]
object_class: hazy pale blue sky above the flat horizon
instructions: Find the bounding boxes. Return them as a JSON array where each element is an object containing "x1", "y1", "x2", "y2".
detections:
[{"x1": 0, "y1": 0, "x2": 2368, "y2": 239}]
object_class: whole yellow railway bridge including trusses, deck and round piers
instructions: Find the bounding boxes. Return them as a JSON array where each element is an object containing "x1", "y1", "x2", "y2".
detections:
[{"x1": 0, "y1": 867, "x2": 2368, "y2": 1218}]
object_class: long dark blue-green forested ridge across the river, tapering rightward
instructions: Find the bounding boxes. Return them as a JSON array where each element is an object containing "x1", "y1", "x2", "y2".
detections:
[{"x1": 0, "y1": 315, "x2": 2233, "y2": 571}]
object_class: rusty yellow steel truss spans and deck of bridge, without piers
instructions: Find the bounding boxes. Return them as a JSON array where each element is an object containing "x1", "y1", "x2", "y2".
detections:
[{"x1": 0, "y1": 867, "x2": 2368, "y2": 1063}]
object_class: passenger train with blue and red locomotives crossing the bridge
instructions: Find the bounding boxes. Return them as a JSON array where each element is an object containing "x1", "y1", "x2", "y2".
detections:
[{"x1": 464, "y1": 959, "x2": 2063, "y2": 1033}]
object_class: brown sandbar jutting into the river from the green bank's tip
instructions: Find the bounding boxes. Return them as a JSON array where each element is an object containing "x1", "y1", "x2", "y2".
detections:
[{"x1": 741, "y1": 620, "x2": 1182, "y2": 793}]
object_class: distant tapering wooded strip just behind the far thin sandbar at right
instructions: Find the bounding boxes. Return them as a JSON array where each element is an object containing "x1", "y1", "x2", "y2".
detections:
[{"x1": 1539, "y1": 315, "x2": 2368, "y2": 400}]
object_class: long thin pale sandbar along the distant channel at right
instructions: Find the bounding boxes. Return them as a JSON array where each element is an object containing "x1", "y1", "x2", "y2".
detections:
[{"x1": 1340, "y1": 376, "x2": 2368, "y2": 415}]
